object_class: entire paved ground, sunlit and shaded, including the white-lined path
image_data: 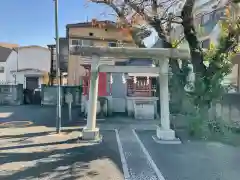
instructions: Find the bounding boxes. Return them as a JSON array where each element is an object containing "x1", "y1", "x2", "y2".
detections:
[{"x1": 0, "y1": 106, "x2": 240, "y2": 180}]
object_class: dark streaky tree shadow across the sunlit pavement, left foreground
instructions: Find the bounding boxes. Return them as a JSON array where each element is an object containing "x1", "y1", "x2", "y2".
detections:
[{"x1": 0, "y1": 132, "x2": 122, "y2": 180}]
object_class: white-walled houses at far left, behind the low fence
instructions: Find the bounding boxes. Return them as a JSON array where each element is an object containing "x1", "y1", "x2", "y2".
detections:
[{"x1": 0, "y1": 46, "x2": 50, "y2": 89}]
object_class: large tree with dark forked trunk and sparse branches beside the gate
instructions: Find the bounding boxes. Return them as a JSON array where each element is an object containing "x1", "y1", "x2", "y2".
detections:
[{"x1": 89, "y1": 0, "x2": 240, "y2": 108}]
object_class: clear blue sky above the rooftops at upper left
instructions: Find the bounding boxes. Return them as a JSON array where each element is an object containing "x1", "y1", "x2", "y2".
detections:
[{"x1": 0, "y1": 0, "x2": 112, "y2": 46}]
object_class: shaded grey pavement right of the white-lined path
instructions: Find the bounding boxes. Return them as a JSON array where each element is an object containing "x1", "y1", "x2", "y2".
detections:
[{"x1": 137, "y1": 131, "x2": 240, "y2": 180}]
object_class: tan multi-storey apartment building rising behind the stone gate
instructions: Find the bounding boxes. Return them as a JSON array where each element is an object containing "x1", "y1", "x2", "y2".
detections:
[{"x1": 66, "y1": 20, "x2": 135, "y2": 86}]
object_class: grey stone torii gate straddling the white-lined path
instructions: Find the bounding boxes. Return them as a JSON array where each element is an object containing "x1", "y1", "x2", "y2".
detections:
[{"x1": 77, "y1": 47, "x2": 190, "y2": 141}]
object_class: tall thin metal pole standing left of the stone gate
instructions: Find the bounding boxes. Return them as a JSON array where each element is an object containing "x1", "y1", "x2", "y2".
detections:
[{"x1": 54, "y1": 0, "x2": 62, "y2": 134}]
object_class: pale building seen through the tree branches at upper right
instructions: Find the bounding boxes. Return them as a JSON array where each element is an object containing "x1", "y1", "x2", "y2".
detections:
[{"x1": 171, "y1": 0, "x2": 240, "y2": 92}]
